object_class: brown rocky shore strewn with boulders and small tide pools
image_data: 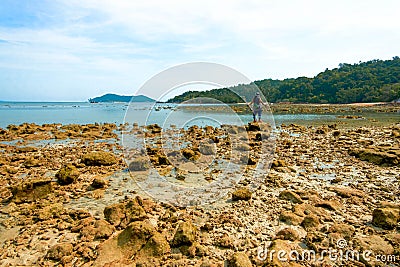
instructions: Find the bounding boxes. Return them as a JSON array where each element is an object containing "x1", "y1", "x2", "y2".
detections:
[{"x1": 0, "y1": 120, "x2": 400, "y2": 267}]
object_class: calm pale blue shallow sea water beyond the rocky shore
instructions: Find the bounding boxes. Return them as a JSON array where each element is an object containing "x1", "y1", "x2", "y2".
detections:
[{"x1": 0, "y1": 102, "x2": 400, "y2": 128}]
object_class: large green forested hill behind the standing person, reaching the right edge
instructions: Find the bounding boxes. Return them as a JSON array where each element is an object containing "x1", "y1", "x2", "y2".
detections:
[{"x1": 168, "y1": 56, "x2": 400, "y2": 103}]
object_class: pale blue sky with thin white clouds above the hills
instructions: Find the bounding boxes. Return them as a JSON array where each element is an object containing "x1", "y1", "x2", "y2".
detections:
[{"x1": 0, "y1": 0, "x2": 400, "y2": 101}]
